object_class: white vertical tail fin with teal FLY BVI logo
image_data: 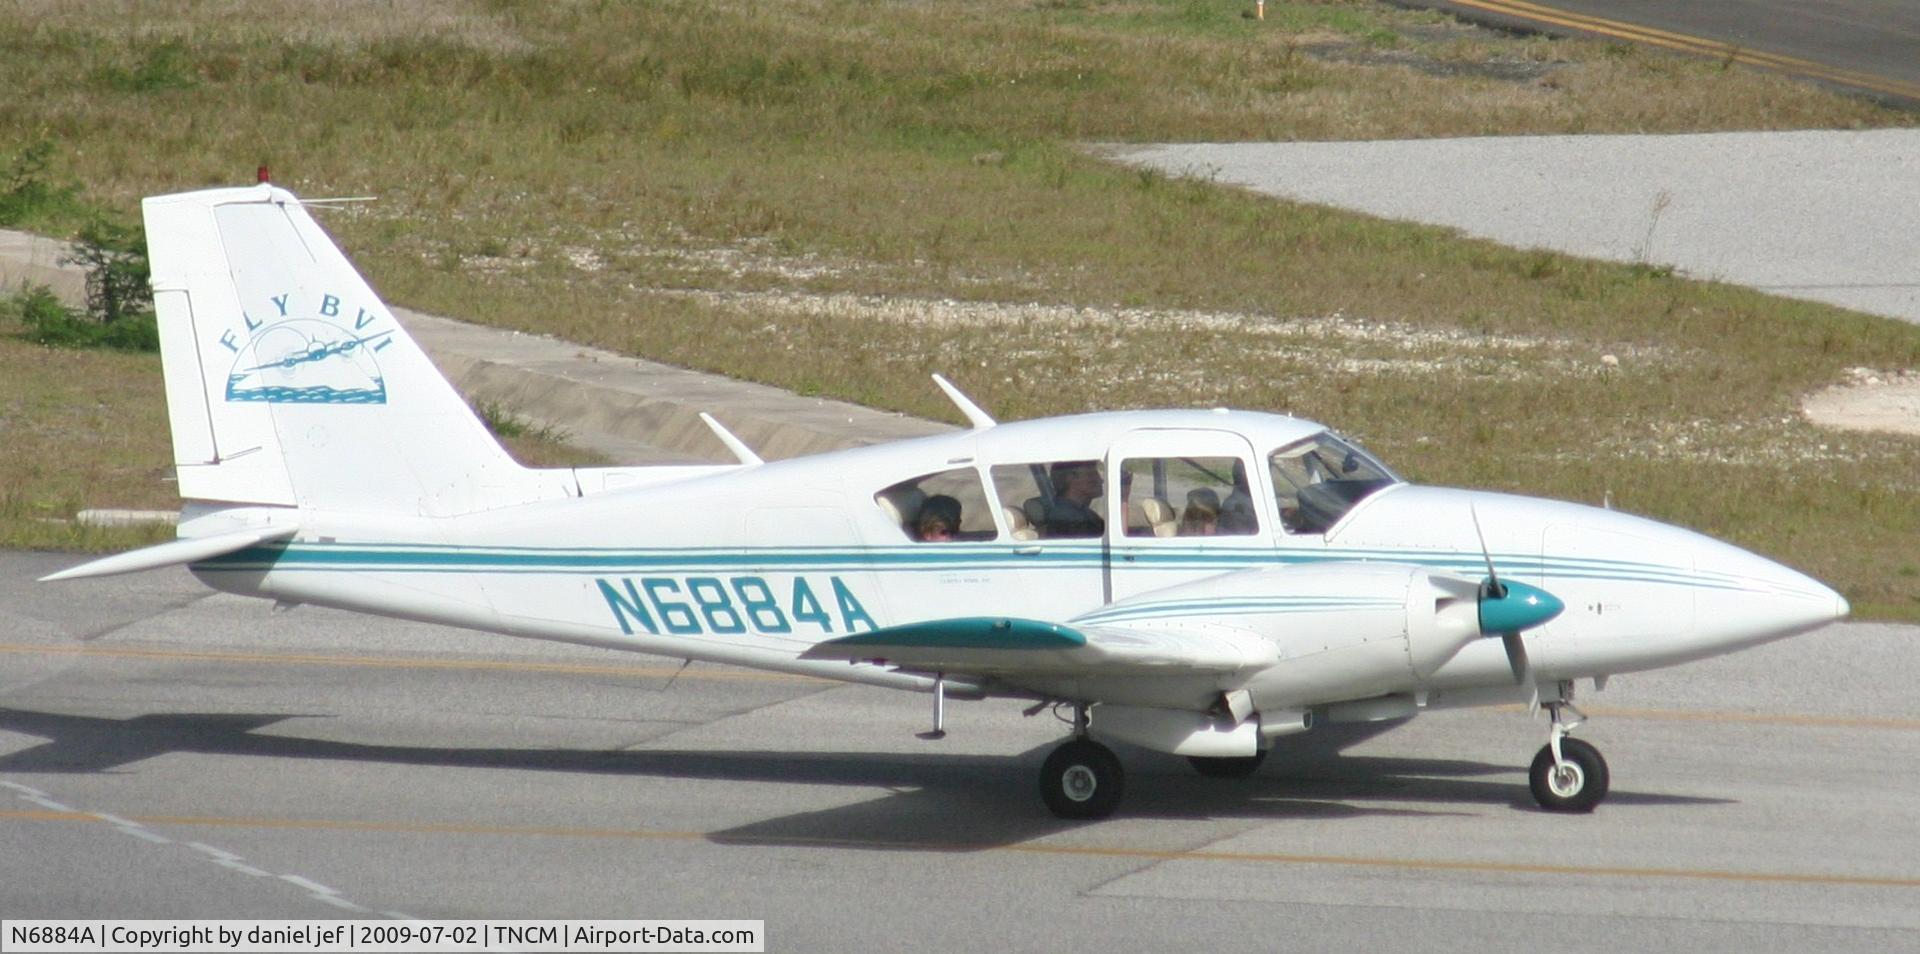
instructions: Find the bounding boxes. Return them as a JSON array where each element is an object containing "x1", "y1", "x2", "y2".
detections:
[{"x1": 142, "y1": 184, "x2": 547, "y2": 516}]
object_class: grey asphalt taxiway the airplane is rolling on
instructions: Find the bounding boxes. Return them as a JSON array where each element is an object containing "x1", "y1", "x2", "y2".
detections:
[{"x1": 0, "y1": 555, "x2": 1920, "y2": 954}]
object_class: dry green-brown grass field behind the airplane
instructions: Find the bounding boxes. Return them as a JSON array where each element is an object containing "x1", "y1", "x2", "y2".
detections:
[{"x1": 0, "y1": 0, "x2": 1920, "y2": 618}]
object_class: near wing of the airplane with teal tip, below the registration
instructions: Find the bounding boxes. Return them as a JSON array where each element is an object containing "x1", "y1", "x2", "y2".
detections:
[{"x1": 801, "y1": 616, "x2": 1279, "y2": 676}]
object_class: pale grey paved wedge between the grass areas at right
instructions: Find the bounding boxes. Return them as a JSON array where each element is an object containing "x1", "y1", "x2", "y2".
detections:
[{"x1": 1106, "y1": 129, "x2": 1920, "y2": 322}]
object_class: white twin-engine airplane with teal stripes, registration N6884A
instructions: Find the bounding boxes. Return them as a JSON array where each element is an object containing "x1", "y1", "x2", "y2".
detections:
[{"x1": 48, "y1": 184, "x2": 1847, "y2": 818}]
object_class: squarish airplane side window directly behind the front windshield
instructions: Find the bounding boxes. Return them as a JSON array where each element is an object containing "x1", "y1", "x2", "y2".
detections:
[{"x1": 1119, "y1": 457, "x2": 1260, "y2": 537}]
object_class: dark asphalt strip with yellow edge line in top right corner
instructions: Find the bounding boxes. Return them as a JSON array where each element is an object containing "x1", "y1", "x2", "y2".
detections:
[{"x1": 1394, "y1": 0, "x2": 1920, "y2": 106}]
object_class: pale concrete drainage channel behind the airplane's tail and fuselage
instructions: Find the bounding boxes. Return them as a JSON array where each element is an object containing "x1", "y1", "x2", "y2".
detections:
[{"x1": 0, "y1": 228, "x2": 952, "y2": 526}]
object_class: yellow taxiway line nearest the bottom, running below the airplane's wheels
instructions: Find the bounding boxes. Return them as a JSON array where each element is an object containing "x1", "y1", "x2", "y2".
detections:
[{"x1": 0, "y1": 810, "x2": 1920, "y2": 889}]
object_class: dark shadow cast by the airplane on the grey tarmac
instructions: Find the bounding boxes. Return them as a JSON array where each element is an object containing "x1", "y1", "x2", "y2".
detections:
[{"x1": 0, "y1": 708, "x2": 1726, "y2": 850}]
